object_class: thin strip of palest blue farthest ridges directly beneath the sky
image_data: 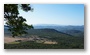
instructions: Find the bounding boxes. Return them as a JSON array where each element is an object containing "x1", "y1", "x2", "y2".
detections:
[{"x1": 34, "y1": 25, "x2": 84, "y2": 31}]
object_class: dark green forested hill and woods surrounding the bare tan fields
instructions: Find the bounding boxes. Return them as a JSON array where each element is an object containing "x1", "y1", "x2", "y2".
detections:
[{"x1": 4, "y1": 29, "x2": 84, "y2": 49}]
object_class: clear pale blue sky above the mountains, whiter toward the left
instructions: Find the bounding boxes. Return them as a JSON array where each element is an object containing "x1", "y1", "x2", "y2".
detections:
[{"x1": 20, "y1": 4, "x2": 84, "y2": 25}]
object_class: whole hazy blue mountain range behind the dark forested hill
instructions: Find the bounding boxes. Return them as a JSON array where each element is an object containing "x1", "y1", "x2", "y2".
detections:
[{"x1": 4, "y1": 24, "x2": 84, "y2": 36}]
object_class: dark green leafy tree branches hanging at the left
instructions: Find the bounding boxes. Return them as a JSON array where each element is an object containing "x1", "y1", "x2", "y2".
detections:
[{"x1": 4, "y1": 4, "x2": 33, "y2": 37}]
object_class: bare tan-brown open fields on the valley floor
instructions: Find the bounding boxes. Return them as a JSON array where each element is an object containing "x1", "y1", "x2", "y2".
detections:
[{"x1": 4, "y1": 36, "x2": 57, "y2": 44}]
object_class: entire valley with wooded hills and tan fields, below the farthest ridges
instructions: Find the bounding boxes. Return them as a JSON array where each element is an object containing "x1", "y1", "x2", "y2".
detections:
[{"x1": 4, "y1": 25, "x2": 84, "y2": 49}]
